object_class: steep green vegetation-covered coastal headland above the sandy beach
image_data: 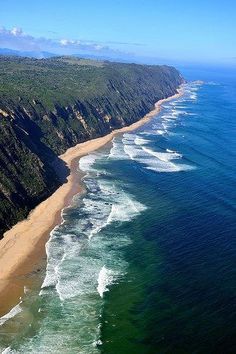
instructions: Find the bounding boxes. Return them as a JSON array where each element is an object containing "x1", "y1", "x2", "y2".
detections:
[{"x1": 0, "y1": 57, "x2": 182, "y2": 235}]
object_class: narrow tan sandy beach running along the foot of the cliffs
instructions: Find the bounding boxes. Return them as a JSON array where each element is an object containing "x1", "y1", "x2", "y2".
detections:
[{"x1": 0, "y1": 87, "x2": 184, "y2": 317}]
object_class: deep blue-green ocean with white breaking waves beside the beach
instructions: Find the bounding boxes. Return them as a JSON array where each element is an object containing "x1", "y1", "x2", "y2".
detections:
[{"x1": 0, "y1": 68, "x2": 236, "y2": 354}]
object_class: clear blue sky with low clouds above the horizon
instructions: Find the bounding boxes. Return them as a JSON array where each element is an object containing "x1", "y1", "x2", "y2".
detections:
[{"x1": 0, "y1": 0, "x2": 236, "y2": 64}]
